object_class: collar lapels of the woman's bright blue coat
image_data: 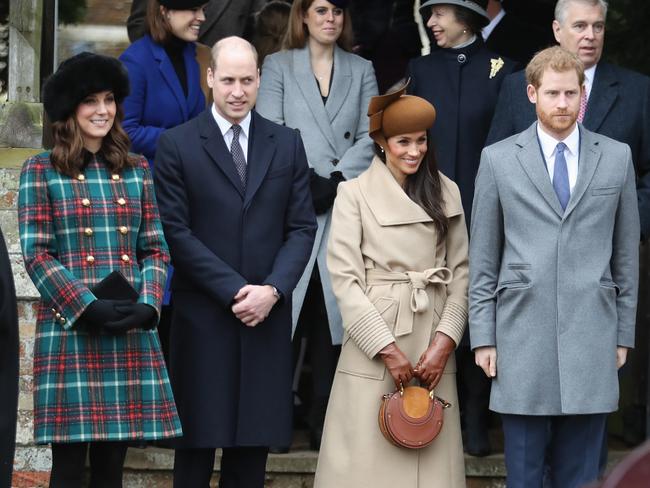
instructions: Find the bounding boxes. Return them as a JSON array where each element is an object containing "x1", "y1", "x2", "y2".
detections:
[{"x1": 145, "y1": 34, "x2": 201, "y2": 120}]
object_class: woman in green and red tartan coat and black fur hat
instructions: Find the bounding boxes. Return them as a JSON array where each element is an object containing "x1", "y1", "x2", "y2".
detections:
[{"x1": 18, "y1": 53, "x2": 181, "y2": 488}]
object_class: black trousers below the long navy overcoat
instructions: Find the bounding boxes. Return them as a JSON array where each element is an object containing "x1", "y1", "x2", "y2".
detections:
[{"x1": 174, "y1": 447, "x2": 269, "y2": 488}]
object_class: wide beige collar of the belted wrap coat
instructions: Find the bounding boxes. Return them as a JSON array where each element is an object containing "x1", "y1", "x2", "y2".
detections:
[{"x1": 359, "y1": 156, "x2": 462, "y2": 226}]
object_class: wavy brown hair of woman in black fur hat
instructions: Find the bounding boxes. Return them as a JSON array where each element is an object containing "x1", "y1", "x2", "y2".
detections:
[{"x1": 50, "y1": 104, "x2": 138, "y2": 177}]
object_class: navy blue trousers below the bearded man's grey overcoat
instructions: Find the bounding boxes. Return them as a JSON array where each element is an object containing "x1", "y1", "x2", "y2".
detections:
[{"x1": 501, "y1": 414, "x2": 607, "y2": 488}]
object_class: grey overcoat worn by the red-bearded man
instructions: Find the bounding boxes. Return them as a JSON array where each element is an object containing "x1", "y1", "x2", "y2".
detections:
[{"x1": 470, "y1": 123, "x2": 639, "y2": 415}]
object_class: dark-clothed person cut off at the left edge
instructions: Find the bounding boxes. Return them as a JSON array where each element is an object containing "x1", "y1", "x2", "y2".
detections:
[{"x1": 0, "y1": 230, "x2": 18, "y2": 487}]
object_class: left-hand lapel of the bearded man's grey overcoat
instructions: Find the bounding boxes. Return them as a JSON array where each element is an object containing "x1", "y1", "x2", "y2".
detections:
[{"x1": 515, "y1": 122, "x2": 564, "y2": 217}]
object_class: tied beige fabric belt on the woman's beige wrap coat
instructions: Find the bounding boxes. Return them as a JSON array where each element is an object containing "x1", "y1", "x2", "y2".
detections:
[{"x1": 366, "y1": 267, "x2": 453, "y2": 337}]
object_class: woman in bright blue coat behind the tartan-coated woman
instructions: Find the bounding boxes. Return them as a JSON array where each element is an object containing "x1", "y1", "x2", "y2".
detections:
[{"x1": 120, "y1": 0, "x2": 206, "y2": 164}]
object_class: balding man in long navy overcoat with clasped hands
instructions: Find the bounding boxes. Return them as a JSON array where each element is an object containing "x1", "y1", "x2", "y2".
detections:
[{"x1": 155, "y1": 37, "x2": 316, "y2": 488}]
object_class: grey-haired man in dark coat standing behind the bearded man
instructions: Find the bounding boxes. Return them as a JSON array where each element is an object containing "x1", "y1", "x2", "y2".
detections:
[{"x1": 486, "y1": 0, "x2": 650, "y2": 237}]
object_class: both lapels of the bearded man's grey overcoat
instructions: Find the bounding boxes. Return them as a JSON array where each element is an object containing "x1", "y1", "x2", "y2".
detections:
[{"x1": 515, "y1": 122, "x2": 601, "y2": 219}]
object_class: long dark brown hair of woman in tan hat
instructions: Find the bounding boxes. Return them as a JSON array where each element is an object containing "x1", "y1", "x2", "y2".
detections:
[{"x1": 375, "y1": 138, "x2": 449, "y2": 242}]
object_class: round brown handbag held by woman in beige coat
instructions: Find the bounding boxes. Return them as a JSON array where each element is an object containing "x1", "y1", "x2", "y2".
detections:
[{"x1": 379, "y1": 386, "x2": 451, "y2": 449}]
